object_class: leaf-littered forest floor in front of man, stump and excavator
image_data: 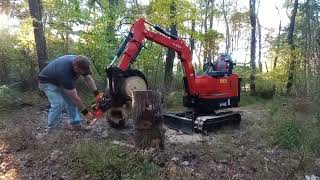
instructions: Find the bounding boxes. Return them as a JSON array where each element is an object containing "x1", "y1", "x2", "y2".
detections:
[{"x1": 0, "y1": 94, "x2": 320, "y2": 179}]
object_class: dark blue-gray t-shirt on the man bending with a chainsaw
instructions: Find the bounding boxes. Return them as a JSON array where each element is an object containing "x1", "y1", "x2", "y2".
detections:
[{"x1": 38, "y1": 55, "x2": 79, "y2": 90}]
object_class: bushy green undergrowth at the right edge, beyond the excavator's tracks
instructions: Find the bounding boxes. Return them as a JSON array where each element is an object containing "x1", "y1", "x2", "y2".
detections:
[{"x1": 266, "y1": 97, "x2": 320, "y2": 155}]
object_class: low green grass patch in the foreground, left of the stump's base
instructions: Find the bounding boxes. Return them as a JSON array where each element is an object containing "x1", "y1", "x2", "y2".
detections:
[{"x1": 75, "y1": 143, "x2": 158, "y2": 179}]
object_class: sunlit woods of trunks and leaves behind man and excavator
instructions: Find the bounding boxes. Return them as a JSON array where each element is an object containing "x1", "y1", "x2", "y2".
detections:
[{"x1": 0, "y1": 0, "x2": 320, "y2": 95}]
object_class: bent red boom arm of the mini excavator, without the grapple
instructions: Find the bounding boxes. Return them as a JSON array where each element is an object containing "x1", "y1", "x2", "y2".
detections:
[{"x1": 107, "y1": 18, "x2": 197, "y2": 95}]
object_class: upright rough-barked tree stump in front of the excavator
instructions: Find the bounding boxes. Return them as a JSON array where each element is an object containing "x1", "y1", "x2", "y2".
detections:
[{"x1": 132, "y1": 90, "x2": 164, "y2": 149}]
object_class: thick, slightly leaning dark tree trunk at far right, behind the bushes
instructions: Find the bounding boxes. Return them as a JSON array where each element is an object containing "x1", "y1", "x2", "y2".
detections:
[{"x1": 286, "y1": 0, "x2": 299, "y2": 94}]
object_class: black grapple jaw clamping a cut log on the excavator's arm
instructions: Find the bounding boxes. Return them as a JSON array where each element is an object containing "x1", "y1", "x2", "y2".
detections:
[{"x1": 92, "y1": 66, "x2": 147, "y2": 128}]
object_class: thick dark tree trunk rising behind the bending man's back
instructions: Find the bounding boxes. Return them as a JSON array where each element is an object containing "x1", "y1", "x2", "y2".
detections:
[{"x1": 29, "y1": 0, "x2": 48, "y2": 71}]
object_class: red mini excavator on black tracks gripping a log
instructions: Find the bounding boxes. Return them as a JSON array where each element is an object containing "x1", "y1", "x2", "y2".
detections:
[{"x1": 92, "y1": 18, "x2": 241, "y2": 133}]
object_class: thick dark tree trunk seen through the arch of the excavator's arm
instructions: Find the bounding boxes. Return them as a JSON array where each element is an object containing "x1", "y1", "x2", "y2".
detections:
[{"x1": 164, "y1": 3, "x2": 178, "y2": 92}]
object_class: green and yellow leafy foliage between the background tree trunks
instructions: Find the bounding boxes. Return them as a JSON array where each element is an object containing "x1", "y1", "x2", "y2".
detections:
[{"x1": 0, "y1": 0, "x2": 320, "y2": 99}]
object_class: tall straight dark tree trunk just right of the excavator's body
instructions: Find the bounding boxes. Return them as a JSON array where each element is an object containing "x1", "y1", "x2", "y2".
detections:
[{"x1": 250, "y1": 0, "x2": 256, "y2": 94}]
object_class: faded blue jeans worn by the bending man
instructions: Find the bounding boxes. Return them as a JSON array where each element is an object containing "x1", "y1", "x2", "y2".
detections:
[{"x1": 39, "y1": 83, "x2": 81, "y2": 128}]
